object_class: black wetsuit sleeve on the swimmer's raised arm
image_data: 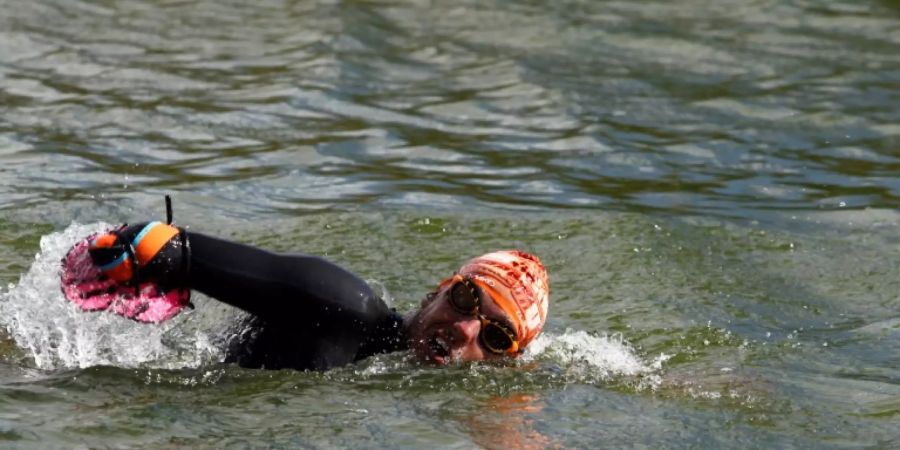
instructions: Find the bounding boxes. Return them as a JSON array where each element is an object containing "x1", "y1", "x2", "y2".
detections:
[{"x1": 189, "y1": 232, "x2": 391, "y2": 327}]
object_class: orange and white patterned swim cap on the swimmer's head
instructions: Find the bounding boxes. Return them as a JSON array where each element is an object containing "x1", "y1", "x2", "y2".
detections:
[{"x1": 459, "y1": 250, "x2": 550, "y2": 350}]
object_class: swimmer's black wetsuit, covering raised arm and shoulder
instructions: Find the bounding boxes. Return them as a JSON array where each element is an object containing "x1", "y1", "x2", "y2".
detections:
[{"x1": 188, "y1": 232, "x2": 406, "y2": 370}]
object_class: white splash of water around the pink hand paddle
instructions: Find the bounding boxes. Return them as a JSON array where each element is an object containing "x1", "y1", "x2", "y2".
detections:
[{"x1": 0, "y1": 223, "x2": 222, "y2": 370}]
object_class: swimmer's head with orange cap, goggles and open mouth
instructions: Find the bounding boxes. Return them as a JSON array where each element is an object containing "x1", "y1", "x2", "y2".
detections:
[{"x1": 407, "y1": 250, "x2": 550, "y2": 364}]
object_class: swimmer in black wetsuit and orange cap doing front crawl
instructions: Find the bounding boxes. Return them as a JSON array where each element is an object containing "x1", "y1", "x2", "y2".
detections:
[{"x1": 82, "y1": 222, "x2": 549, "y2": 370}]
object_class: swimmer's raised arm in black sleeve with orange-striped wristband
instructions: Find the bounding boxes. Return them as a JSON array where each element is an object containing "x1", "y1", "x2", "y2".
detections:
[{"x1": 90, "y1": 222, "x2": 389, "y2": 328}]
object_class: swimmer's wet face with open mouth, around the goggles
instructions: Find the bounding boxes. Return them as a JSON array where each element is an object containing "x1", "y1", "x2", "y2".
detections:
[{"x1": 407, "y1": 274, "x2": 515, "y2": 365}]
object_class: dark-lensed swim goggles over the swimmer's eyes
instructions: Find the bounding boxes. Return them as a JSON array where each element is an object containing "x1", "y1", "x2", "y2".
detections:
[{"x1": 448, "y1": 274, "x2": 519, "y2": 355}]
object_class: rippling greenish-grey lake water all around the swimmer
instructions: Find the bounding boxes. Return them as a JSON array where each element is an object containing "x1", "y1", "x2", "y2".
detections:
[{"x1": 0, "y1": 0, "x2": 900, "y2": 449}]
